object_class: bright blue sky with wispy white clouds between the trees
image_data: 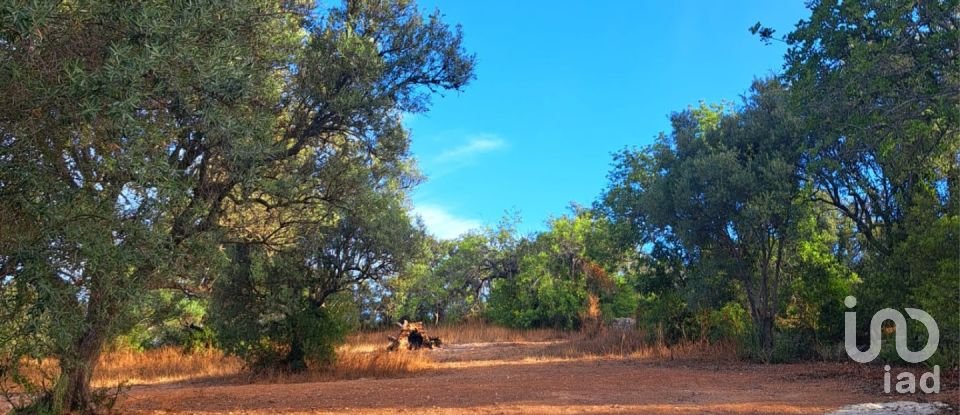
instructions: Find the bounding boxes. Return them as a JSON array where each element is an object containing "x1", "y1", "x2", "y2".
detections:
[{"x1": 405, "y1": 0, "x2": 808, "y2": 238}]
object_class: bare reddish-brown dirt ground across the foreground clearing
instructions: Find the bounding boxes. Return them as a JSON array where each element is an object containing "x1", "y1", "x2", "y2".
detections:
[{"x1": 117, "y1": 342, "x2": 957, "y2": 415}]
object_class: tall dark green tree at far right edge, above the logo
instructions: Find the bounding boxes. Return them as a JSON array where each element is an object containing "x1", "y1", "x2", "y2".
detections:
[{"x1": 784, "y1": 0, "x2": 960, "y2": 364}]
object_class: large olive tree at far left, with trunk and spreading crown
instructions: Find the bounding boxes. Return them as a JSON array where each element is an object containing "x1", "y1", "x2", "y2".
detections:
[{"x1": 0, "y1": 0, "x2": 473, "y2": 412}]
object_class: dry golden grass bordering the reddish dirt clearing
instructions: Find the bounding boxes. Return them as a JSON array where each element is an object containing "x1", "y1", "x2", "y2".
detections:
[{"x1": 5, "y1": 323, "x2": 736, "y2": 394}]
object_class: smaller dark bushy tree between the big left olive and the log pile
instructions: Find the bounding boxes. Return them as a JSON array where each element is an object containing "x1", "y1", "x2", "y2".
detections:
[{"x1": 211, "y1": 187, "x2": 422, "y2": 371}]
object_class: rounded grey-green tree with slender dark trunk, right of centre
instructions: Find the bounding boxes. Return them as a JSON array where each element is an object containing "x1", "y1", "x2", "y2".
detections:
[{"x1": 605, "y1": 81, "x2": 805, "y2": 358}]
